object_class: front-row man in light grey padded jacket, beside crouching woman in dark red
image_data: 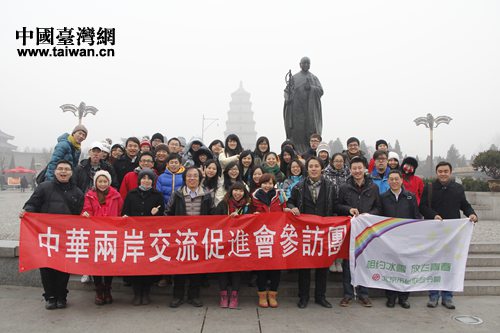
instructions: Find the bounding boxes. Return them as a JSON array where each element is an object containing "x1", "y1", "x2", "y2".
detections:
[{"x1": 166, "y1": 166, "x2": 214, "y2": 308}]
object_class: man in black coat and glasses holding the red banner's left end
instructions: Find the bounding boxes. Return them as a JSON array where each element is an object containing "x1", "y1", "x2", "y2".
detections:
[{"x1": 19, "y1": 160, "x2": 83, "y2": 310}]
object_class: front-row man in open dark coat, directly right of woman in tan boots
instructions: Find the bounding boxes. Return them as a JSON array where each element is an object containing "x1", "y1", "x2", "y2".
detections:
[{"x1": 287, "y1": 156, "x2": 335, "y2": 309}]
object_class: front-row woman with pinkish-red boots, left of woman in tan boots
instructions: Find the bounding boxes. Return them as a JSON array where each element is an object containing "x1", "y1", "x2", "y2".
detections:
[{"x1": 215, "y1": 182, "x2": 252, "y2": 309}]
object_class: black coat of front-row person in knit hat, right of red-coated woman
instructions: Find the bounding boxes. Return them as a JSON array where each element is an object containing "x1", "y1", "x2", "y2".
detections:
[{"x1": 122, "y1": 188, "x2": 165, "y2": 216}]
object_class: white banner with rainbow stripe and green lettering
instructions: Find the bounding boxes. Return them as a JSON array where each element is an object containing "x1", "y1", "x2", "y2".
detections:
[{"x1": 349, "y1": 215, "x2": 474, "y2": 291}]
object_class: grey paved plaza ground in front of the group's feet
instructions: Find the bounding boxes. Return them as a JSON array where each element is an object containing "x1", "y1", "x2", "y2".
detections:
[{"x1": 0, "y1": 286, "x2": 500, "y2": 333}]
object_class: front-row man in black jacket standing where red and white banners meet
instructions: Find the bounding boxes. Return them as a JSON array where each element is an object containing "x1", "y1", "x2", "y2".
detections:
[{"x1": 336, "y1": 156, "x2": 381, "y2": 307}]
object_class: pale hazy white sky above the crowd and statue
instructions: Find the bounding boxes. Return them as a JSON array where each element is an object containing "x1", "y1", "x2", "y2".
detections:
[{"x1": 0, "y1": 0, "x2": 500, "y2": 157}]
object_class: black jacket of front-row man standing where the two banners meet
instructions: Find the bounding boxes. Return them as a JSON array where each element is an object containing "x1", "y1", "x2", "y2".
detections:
[{"x1": 336, "y1": 175, "x2": 382, "y2": 216}]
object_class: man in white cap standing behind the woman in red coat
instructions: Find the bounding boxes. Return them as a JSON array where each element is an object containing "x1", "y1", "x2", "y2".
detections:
[{"x1": 75, "y1": 141, "x2": 118, "y2": 193}]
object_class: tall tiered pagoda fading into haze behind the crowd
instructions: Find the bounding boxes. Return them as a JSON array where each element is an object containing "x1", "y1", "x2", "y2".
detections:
[{"x1": 224, "y1": 82, "x2": 257, "y2": 150}]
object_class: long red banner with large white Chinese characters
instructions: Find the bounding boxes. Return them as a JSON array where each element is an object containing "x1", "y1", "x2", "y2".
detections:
[{"x1": 19, "y1": 213, "x2": 350, "y2": 276}]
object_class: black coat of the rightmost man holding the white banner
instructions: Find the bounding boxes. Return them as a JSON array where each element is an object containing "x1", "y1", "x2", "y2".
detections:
[{"x1": 420, "y1": 180, "x2": 475, "y2": 219}]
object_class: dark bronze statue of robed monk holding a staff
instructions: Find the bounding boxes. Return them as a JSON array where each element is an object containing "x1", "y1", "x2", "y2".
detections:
[{"x1": 283, "y1": 57, "x2": 323, "y2": 153}]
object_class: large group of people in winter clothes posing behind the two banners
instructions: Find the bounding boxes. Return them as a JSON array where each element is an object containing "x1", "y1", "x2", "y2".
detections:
[{"x1": 20, "y1": 125, "x2": 477, "y2": 309}]
